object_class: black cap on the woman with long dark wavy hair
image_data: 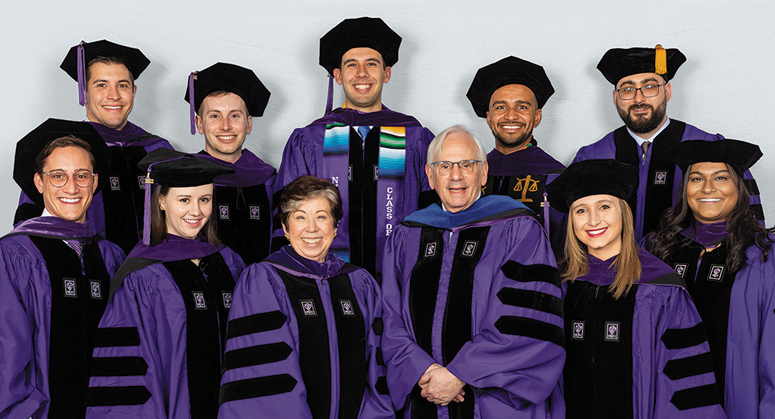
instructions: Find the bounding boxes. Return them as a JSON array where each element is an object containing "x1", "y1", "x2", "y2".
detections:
[{"x1": 665, "y1": 139, "x2": 764, "y2": 178}]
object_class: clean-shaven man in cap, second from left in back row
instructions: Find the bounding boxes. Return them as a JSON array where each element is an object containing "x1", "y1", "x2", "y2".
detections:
[{"x1": 185, "y1": 63, "x2": 276, "y2": 265}]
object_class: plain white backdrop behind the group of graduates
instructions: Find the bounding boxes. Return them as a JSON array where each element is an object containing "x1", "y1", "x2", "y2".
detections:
[{"x1": 0, "y1": 0, "x2": 775, "y2": 228}]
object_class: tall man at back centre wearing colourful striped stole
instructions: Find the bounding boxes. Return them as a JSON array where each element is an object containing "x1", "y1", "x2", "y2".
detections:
[{"x1": 272, "y1": 17, "x2": 436, "y2": 281}]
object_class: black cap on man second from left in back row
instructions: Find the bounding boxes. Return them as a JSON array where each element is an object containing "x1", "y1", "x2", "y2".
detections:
[{"x1": 184, "y1": 63, "x2": 270, "y2": 134}]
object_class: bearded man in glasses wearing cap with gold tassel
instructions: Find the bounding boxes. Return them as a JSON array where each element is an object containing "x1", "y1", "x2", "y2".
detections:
[{"x1": 573, "y1": 45, "x2": 764, "y2": 240}]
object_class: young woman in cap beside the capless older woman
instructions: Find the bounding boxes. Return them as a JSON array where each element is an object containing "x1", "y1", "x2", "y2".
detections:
[{"x1": 87, "y1": 149, "x2": 245, "y2": 419}]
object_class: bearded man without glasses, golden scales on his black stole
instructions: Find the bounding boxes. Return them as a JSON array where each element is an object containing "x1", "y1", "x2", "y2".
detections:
[{"x1": 466, "y1": 57, "x2": 565, "y2": 255}]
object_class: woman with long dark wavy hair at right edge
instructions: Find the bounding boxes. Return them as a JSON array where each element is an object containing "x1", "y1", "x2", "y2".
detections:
[{"x1": 646, "y1": 140, "x2": 775, "y2": 418}]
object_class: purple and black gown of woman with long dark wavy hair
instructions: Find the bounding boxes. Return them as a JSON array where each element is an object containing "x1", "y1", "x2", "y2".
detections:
[{"x1": 666, "y1": 222, "x2": 775, "y2": 419}]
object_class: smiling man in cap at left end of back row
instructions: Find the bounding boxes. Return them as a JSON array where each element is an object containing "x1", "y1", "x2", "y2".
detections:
[{"x1": 14, "y1": 40, "x2": 172, "y2": 253}]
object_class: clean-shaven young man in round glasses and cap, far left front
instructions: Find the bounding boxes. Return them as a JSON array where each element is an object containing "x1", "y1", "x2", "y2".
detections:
[{"x1": 0, "y1": 119, "x2": 124, "y2": 419}]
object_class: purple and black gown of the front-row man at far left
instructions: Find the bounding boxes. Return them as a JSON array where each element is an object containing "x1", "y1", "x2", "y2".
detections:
[{"x1": 0, "y1": 217, "x2": 124, "y2": 419}]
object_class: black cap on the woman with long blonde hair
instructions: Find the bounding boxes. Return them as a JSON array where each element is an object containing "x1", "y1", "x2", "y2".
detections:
[{"x1": 546, "y1": 159, "x2": 638, "y2": 213}]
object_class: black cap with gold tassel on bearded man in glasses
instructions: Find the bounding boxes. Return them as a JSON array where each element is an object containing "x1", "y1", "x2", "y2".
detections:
[{"x1": 597, "y1": 45, "x2": 686, "y2": 86}]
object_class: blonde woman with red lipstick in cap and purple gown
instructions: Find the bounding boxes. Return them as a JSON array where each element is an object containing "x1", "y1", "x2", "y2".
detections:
[{"x1": 547, "y1": 160, "x2": 724, "y2": 419}]
